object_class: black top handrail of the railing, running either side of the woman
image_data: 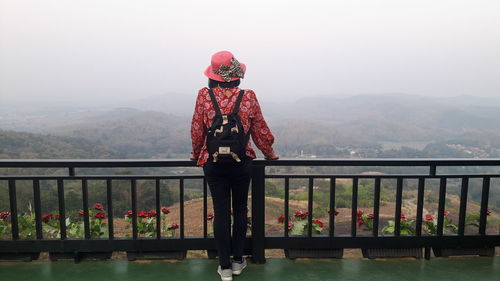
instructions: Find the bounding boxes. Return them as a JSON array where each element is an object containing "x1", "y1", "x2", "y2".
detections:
[{"x1": 0, "y1": 158, "x2": 500, "y2": 168}]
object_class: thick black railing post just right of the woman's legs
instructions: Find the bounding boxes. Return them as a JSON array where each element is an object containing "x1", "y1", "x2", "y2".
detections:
[{"x1": 252, "y1": 162, "x2": 266, "y2": 263}]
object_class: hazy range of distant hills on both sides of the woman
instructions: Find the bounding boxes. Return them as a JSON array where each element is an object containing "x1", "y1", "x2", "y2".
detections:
[{"x1": 0, "y1": 94, "x2": 500, "y2": 158}]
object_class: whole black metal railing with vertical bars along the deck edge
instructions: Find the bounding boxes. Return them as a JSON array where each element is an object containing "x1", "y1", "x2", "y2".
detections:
[{"x1": 0, "y1": 159, "x2": 500, "y2": 263}]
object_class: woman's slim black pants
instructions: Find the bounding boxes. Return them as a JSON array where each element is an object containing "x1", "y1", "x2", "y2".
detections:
[{"x1": 203, "y1": 157, "x2": 252, "y2": 266}]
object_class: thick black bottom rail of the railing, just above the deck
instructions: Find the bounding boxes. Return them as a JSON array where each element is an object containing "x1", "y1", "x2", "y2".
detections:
[{"x1": 0, "y1": 235, "x2": 500, "y2": 253}]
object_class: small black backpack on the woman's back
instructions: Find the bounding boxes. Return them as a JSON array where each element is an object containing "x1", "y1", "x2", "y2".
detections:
[{"x1": 207, "y1": 88, "x2": 250, "y2": 163}]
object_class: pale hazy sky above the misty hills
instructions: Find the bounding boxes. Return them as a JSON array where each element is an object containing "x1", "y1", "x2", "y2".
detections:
[{"x1": 0, "y1": 0, "x2": 500, "y2": 102}]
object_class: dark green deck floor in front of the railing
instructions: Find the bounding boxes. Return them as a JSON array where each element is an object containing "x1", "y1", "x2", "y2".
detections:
[{"x1": 0, "y1": 256, "x2": 500, "y2": 281}]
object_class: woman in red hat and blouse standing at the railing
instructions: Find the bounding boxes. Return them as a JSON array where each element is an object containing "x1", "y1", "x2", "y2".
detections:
[{"x1": 190, "y1": 51, "x2": 279, "y2": 281}]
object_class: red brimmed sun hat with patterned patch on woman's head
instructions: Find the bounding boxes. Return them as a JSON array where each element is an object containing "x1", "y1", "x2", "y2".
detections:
[{"x1": 205, "y1": 51, "x2": 246, "y2": 82}]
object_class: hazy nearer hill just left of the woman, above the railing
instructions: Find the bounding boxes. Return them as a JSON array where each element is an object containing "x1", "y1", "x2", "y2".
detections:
[{"x1": 43, "y1": 110, "x2": 191, "y2": 158}]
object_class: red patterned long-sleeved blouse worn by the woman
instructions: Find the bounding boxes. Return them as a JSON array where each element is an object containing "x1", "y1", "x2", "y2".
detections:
[{"x1": 191, "y1": 87, "x2": 274, "y2": 166}]
